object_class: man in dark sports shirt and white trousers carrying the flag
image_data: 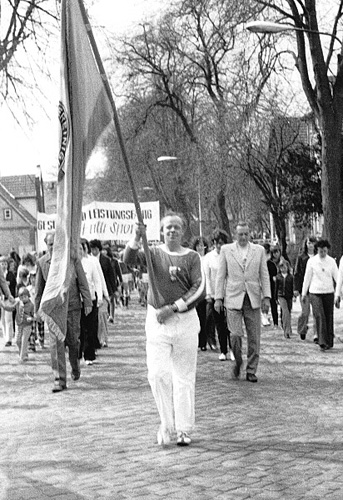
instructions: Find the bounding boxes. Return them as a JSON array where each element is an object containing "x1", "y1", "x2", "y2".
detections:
[{"x1": 124, "y1": 213, "x2": 205, "y2": 446}]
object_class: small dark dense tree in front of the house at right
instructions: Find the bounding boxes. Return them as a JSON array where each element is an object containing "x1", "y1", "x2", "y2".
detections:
[{"x1": 243, "y1": 112, "x2": 322, "y2": 257}]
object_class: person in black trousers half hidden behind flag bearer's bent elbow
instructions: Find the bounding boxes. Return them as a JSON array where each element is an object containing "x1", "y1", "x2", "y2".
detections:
[{"x1": 191, "y1": 236, "x2": 217, "y2": 351}]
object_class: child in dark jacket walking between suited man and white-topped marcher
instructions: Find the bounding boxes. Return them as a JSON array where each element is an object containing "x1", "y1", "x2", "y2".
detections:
[{"x1": 275, "y1": 259, "x2": 294, "y2": 339}]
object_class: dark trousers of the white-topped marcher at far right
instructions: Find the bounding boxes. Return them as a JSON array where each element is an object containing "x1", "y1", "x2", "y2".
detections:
[{"x1": 310, "y1": 293, "x2": 334, "y2": 347}]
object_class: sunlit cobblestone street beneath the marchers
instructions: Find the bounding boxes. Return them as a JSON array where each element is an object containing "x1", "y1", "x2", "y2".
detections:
[{"x1": 0, "y1": 297, "x2": 343, "y2": 500}]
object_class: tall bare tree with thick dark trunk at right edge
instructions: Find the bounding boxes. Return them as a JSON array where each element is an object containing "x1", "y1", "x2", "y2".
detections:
[{"x1": 255, "y1": 0, "x2": 343, "y2": 258}]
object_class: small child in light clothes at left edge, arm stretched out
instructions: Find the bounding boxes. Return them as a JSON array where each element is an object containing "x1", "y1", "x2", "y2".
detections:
[{"x1": 0, "y1": 286, "x2": 34, "y2": 362}]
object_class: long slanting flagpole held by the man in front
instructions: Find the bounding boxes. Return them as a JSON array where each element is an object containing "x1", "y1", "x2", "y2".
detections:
[{"x1": 77, "y1": 0, "x2": 163, "y2": 307}]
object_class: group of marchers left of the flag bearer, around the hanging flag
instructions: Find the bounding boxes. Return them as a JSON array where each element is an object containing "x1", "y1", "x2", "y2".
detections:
[{"x1": 0, "y1": 237, "x2": 137, "y2": 392}]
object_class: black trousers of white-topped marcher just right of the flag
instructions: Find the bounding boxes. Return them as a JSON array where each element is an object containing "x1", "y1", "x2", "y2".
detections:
[{"x1": 79, "y1": 299, "x2": 99, "y2": 361}]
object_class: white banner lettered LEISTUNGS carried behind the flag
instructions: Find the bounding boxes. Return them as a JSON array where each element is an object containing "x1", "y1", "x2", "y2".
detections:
[{"x1": 37, "y1": 201, "x2": 160, "y2": 252}]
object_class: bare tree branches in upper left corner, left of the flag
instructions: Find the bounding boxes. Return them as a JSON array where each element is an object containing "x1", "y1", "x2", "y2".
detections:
[{"x1": 0, "y1": 0, "x2": 59, "y2": 121}]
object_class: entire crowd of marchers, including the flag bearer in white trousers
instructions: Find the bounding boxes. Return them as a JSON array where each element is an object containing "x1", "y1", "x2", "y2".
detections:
[{"x1": 0, "y1": 213, "x2": 343, "y2": 446}]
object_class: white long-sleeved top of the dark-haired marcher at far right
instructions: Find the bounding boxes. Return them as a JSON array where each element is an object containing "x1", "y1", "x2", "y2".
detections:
[{"x1": 301, "y1": 255, "x2": 338, "y2": 296}]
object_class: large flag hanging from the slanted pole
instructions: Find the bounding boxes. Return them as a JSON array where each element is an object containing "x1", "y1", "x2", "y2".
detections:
[{"x1": 40, "y1": 0, "x2": 113, "y2": 340}]
